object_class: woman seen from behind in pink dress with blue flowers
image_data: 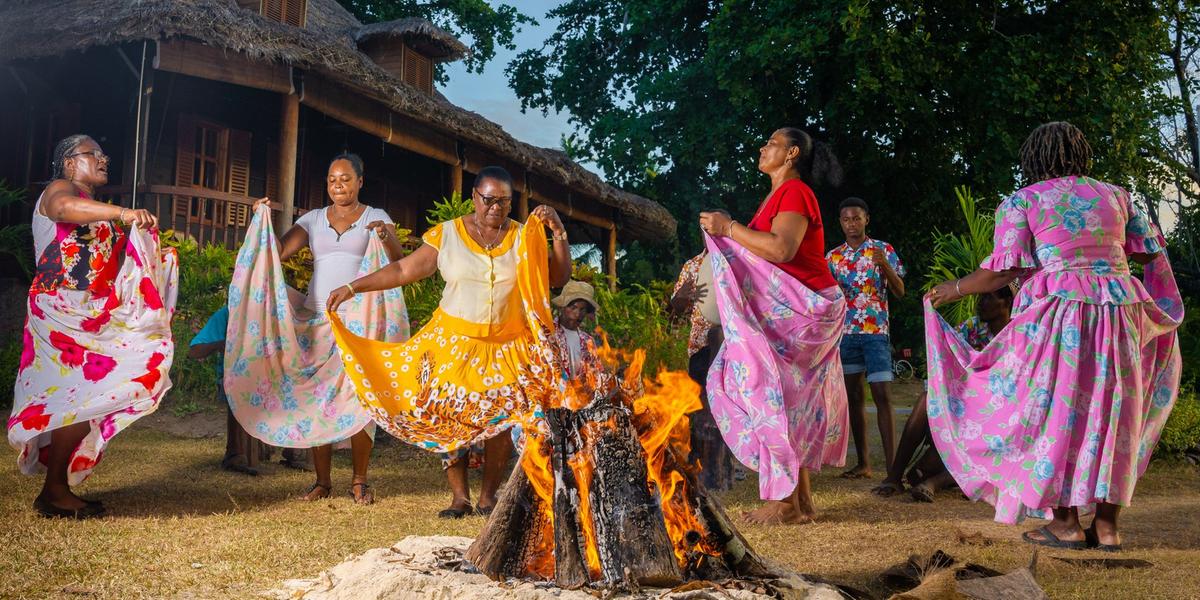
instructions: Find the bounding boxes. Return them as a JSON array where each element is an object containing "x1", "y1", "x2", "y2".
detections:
[{"x1": 925, "y1": 122, "x2": 1183, "y2": 551}]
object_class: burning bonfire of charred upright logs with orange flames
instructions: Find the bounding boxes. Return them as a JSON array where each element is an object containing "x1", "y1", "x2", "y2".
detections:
[{"x1": 466, "y1": 340, "x2": 773, "y2": 590}]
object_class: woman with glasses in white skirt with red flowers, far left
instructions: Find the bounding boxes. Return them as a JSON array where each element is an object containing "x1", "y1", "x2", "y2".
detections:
[{"x1": 8, "y1": 136, "x2": 178, "y2": 518}]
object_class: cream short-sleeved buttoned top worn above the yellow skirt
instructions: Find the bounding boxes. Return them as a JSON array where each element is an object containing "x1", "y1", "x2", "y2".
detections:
[{"x1": 421, "y1": 218, "x2": 521, "y2": 336}]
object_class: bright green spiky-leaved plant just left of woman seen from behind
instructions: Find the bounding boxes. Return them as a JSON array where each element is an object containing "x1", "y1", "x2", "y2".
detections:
[{"x1": 924, "y1": 186, "x2": 996, "y2": 323}]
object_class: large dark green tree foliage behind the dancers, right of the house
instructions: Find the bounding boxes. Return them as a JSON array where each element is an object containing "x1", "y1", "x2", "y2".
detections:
[{"x1": 508, "y1": 0, "x2": 1190, "y2": 348}]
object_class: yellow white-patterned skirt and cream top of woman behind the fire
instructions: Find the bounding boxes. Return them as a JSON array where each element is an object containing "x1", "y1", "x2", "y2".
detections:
[{"x1": 330, "y1": 216, "x2": 562, "y2": 455}]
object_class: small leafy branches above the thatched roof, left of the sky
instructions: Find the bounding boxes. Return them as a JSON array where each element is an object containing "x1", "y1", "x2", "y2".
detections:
[{"x1": 338, "y1": 0, "x2": 536, "y2": 80}]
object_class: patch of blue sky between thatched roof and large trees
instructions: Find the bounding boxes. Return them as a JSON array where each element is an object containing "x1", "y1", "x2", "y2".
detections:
[{"x1": 439, "y1": 0, "x2": 574, "y2": 148}]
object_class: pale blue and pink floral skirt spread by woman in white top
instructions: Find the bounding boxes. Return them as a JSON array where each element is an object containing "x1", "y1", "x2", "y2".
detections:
[{"x1": 224, "y1": 206, "x2": 408, "y2": 448}]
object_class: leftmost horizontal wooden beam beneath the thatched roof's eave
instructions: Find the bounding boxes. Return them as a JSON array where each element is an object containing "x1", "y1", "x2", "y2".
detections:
[{"x1": 154, "y1": 40, "x2": 295, "y2": 94}]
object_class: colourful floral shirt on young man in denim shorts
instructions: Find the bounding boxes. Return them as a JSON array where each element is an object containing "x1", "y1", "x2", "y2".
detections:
[{"x1": 826, "y1": 238, "x2": 905, "y2": 335}]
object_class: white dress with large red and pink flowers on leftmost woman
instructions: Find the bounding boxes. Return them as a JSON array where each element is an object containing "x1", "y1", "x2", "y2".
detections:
[{"x1": 8, "y1": 220, "x2": 179, "y2": 485}]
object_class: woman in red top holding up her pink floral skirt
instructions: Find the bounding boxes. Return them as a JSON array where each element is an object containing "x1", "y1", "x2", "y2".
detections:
[{"x1": 700, "y1": 127, "x2": 846, "y2": 524}]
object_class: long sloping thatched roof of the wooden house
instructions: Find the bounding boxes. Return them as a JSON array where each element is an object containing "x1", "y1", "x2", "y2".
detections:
[{"x1": 0, "y1": 0, "x2": 676, "y2": 240}]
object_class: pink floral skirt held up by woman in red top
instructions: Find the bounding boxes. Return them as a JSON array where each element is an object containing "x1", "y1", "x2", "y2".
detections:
[{"x1": 706, "y1": 236, "x2": 848, "y2": 500}]
